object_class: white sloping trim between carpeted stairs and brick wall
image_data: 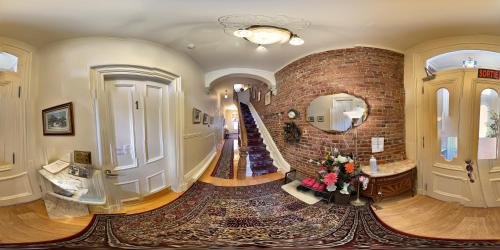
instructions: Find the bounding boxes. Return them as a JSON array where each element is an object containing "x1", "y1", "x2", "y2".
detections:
[{"x1": 248, "y1": 103, "x2": 291, "y2": 173}]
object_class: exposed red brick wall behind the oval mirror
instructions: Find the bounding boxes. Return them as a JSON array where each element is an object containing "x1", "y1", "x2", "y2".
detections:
[{"x1": 252, "y1": 47, "x2": 406, "y2": 175}]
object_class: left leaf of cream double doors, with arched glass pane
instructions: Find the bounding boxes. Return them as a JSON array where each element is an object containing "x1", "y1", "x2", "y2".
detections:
[{"x1": 421, "y1": 70, "x2": 484, "y2": 207}]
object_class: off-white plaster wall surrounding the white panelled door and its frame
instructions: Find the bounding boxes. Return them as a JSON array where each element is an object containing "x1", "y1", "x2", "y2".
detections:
[{"x1": 32, "y1": 37, "x2": 216, "y2": 186}]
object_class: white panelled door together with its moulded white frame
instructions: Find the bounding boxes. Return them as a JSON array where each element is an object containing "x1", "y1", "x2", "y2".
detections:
[{"x1": 92, "y1": 65, "x2": 183, "y2": 211}]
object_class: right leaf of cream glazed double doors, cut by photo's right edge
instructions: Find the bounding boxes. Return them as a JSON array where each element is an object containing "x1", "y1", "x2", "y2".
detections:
[{"x1": 473, "y1": 79, "x2": 500, "y2": 207}]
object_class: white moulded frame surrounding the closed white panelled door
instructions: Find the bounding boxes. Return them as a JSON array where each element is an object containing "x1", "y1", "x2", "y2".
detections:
[{"x1": 90, "y1": 64, "x2": 184, "y2": 191}]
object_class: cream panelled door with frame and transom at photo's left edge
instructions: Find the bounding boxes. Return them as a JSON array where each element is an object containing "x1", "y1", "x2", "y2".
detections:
[{"x1": 0, "y1": 44, "x2": 40, "y2": 206}]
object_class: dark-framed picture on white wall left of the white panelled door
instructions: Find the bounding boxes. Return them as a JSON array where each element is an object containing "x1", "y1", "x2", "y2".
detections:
[{"x1": 42, "y1": 102, "x2": 75, "y2": 135}]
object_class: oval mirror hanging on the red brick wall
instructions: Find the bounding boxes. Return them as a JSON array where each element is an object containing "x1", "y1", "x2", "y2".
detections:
[{"x1": 306, "y1": 93, "x2": 368, "y2": 132}]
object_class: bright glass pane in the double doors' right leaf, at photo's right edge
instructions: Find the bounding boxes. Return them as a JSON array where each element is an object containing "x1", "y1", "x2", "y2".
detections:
[{"x1": 477, "y1": 89, "x2": 500, "y2": 160}]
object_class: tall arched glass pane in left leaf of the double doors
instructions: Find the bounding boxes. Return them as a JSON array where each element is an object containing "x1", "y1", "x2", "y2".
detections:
[{"x1": 436, "y1": 88, "x2": 458, "y2": 161}]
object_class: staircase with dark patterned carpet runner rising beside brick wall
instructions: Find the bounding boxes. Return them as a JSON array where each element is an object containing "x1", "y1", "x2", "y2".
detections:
[{"x1": 241, "y1": 103, "x2": 278, "y2": 176}]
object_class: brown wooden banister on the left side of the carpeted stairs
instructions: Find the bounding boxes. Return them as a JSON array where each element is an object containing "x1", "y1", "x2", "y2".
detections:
[{"x1": 233, "y1": 91, "x2": 248, "y2": 179}]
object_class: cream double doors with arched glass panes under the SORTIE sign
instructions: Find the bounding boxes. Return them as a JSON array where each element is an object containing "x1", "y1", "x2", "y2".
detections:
[{"x1": 422, "y1": 68, "x2": 500, "y2": 207}]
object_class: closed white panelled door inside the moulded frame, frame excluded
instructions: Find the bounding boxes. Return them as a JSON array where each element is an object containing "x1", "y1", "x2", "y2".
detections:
[{"x1": 101, "y1": 80, "x2": 168, "y2": 204}]
